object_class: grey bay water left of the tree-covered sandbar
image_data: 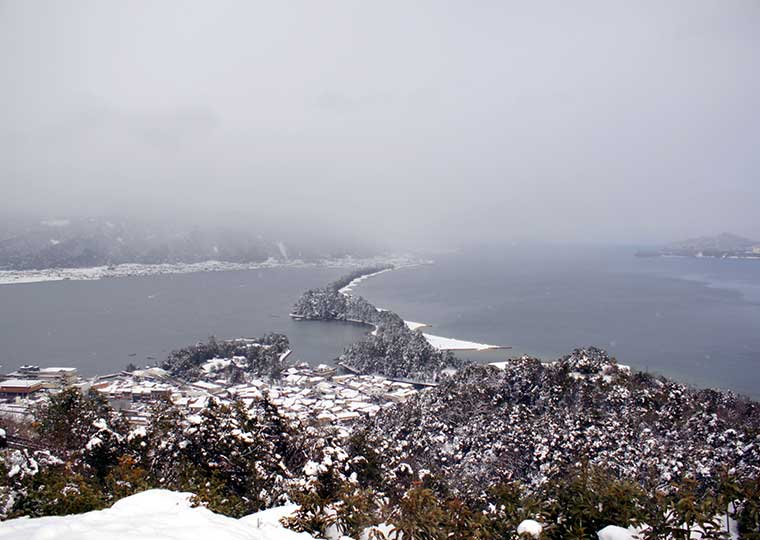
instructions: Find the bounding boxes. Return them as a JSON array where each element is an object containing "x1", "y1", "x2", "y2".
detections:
[{"x1": 0, "y1": 268, "x2": 366, "y2": 375}]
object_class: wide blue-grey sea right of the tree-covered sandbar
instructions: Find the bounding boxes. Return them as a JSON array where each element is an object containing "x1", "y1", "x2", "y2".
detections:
[{"x1": 356, "y1": 247, "x2": 760, "y2": 398}]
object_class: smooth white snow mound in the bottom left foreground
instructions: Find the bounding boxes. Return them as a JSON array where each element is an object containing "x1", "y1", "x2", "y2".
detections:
[{"x1": 0, "y1": 489, "x2": 313, "y2": 540}]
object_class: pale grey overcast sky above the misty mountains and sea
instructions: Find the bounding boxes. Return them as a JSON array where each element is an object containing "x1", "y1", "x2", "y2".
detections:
[{"x1": 0, "y1": 0, "x2": 760, "y2": 247}]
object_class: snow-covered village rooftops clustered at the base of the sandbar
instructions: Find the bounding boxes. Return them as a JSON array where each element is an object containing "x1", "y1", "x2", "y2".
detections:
[{"x1": 0, "y1": 357, "x2": 417, "y2": 427}]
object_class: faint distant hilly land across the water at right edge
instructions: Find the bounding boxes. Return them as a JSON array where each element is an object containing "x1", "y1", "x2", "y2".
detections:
[{"x1": 636, "y1": 233, "x2": 760, "y2": 259}]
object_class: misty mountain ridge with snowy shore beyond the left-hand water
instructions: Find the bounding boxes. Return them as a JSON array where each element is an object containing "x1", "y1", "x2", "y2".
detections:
[{"x1": 0, "y1": 218, "x2": 372, "y2": 270}]
